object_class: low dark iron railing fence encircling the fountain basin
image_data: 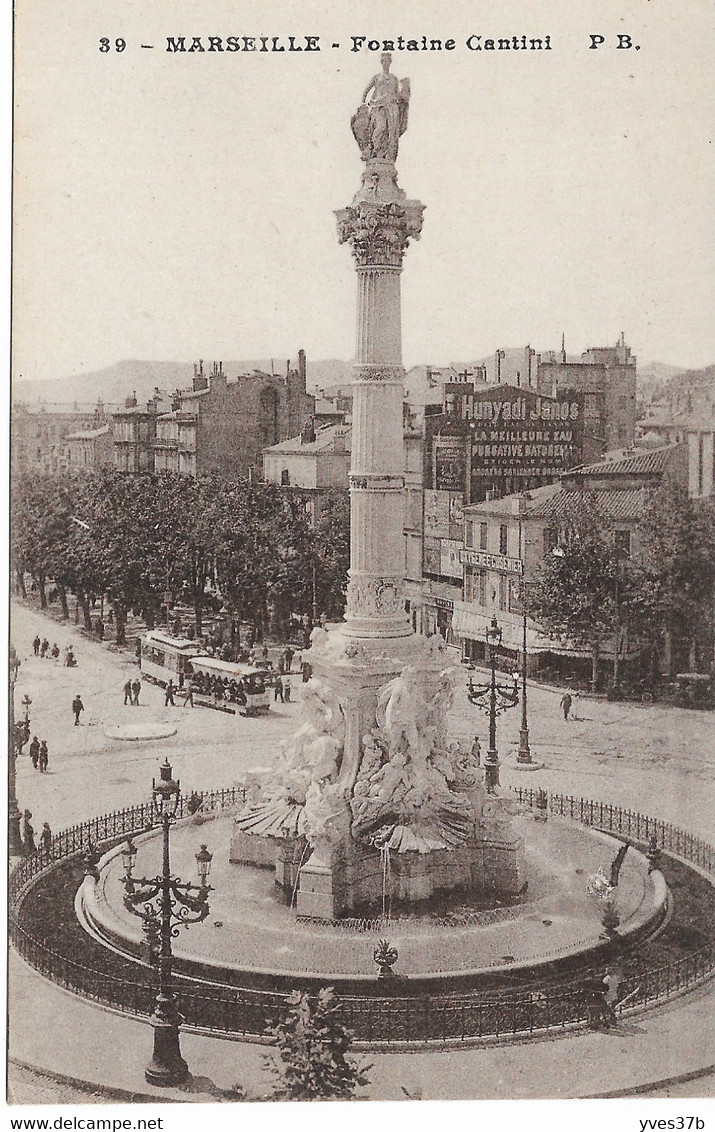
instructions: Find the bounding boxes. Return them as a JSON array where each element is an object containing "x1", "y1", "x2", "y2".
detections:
[{"x1": 10, "y1": 786, "x2": 715, "y2": 1046}]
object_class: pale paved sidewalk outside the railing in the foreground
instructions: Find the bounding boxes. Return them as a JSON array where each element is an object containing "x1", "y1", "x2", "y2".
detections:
[{"x1": 9, "y1": 952, "x2": 715, "y2": 1104}]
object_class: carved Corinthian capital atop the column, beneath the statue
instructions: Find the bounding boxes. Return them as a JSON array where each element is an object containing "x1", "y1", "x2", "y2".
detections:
[{"x1": 336, "y1": 200, "x2": 424, "y2": 267}]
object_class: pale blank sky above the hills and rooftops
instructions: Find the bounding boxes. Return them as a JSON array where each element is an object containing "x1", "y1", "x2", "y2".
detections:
[{"x1": 14, "y1": 0, "x2": 715, "y2": 379}]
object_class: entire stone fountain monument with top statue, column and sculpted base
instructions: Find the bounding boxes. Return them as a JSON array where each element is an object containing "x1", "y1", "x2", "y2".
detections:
[{"x1": 232, "y1": 55, "x2": 526, "y2": 919}]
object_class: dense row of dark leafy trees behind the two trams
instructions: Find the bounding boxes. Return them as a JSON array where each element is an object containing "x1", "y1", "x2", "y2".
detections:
[{"x1": 11, "y1": 469, "x2": 350, "y2": 643}]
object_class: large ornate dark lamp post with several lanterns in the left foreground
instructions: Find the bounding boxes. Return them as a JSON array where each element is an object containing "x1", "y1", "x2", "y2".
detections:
[{"x1": 121, "y1": 760, "x2": 213, "y2": 1084}]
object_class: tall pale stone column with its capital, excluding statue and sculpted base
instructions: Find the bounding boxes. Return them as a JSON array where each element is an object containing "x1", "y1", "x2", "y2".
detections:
[{"x1": 336, "y1": 157, "x2": 424, "y2": 641}]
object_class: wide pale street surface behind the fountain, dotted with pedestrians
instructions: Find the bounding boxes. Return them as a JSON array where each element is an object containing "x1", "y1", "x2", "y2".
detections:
[{"x1": 11, "y1": 603, "x2": 715, "y2": 839}]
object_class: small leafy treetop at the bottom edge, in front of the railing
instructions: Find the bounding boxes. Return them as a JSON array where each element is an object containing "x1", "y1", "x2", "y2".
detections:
[{"x1": 268, "y1": 987, "x2": 371, "y2": 1100}]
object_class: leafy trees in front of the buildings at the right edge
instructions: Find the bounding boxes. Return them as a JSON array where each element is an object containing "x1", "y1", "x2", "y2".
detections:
[{"x1": 528, "y1": 481, "x2": 715, "y2": 688}]
